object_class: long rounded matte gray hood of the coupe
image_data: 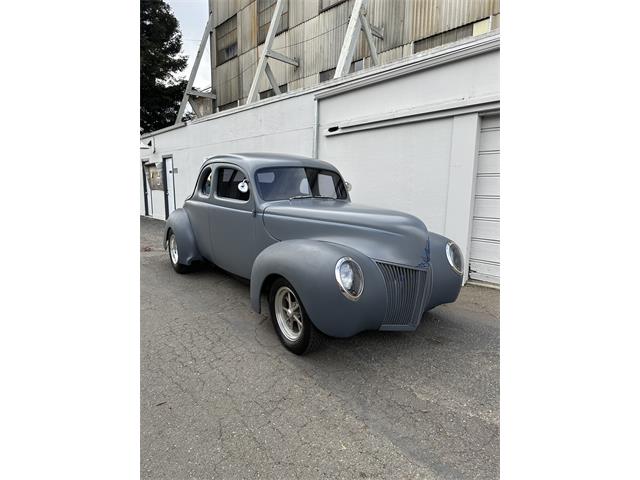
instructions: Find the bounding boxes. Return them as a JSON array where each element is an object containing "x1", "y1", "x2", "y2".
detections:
[{"x1": 263, "y1": 198, "x2": 429, "y2": 268}]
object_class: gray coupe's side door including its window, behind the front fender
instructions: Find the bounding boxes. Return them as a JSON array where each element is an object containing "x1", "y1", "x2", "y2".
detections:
[{"x1": 209, "y1": 163, "x2": 257, "y2": 278}]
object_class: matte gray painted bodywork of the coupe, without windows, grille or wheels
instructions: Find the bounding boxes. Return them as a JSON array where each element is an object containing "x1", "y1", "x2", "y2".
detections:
[{"x1": 165, "y1": 153, "x2": 462, "y2": 337}]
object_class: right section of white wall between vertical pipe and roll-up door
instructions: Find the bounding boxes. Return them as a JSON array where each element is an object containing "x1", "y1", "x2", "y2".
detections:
[{"x1": 318, "y1": 50, "x2": 500, "y2": 281}]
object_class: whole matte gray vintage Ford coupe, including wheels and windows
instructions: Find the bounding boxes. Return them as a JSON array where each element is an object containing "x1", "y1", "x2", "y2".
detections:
[{"x1": 164, "y1": 153, "x2": 463, "y2": 354}]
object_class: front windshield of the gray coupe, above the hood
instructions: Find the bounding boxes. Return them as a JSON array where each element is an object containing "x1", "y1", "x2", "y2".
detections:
[{"x1": 256, "y1": 167, "x2": 347, "y2": 202}]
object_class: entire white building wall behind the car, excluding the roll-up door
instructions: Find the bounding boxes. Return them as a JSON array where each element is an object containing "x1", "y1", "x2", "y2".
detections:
[{"x1": 140, "y1": 37, "x2": 500, "y2": 282}]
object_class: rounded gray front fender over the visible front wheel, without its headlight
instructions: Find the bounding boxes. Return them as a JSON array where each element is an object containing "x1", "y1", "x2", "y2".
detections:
[{"x1": 251, "y1": 240, "x2": 387, "y2": 337}]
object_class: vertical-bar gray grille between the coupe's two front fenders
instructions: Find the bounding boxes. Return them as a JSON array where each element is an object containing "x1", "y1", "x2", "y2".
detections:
[{"x1": 376, "y1": 262, "x2": 431, "y2": 328}]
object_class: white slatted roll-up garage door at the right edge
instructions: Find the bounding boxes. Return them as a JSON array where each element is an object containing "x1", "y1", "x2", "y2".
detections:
[{"x1": 469, "y1": 115, "x2": 500, "y2": 284}]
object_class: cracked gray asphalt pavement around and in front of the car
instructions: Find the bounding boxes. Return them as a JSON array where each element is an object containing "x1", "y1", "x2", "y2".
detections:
[{"x1": 140, "y1": 218, "x2": 500, "y2": 480}]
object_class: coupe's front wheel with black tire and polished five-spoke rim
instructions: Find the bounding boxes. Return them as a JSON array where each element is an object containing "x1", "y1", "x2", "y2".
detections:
[{"x1": 269, "y1": 278, "x2": 322, "y2": 355}]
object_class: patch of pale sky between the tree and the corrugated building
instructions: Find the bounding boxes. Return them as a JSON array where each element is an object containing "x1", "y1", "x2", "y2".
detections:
[{"x1": 165, "y1": 0, "x2": 211, "y2": 88}]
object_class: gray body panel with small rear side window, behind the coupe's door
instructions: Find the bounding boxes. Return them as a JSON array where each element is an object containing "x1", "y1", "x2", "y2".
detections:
[{"x1": 184, "y1": 165, "x2": 214, "y2": 262}]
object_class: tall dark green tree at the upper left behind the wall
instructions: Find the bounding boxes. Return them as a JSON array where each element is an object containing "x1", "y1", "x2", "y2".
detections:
[{"x1": 140, "y1": 0, "x2": 187, "y2": 133}]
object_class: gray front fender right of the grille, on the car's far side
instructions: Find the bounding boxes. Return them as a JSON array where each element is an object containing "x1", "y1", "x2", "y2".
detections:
[{"x1": 426, "y1": 232, "x2": 464, "y2": 310}]
